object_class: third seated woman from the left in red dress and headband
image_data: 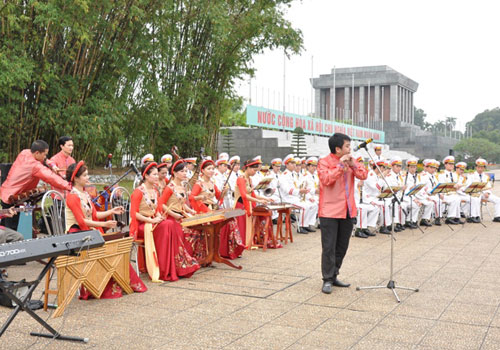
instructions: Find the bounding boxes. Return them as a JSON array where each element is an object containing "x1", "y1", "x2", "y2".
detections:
[{"x1": 159, "y1": 159, "x2": 208, "y2": 263}]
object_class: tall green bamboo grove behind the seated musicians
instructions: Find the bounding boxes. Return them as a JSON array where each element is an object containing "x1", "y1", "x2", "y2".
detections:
[{"x1": 0, "y1": 0, "x2": 302, "y2": 165}]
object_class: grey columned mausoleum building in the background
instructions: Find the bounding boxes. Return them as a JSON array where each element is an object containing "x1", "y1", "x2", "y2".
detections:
[{"x1": 311, "y1": 66, "x2": 418, "y2": 128}]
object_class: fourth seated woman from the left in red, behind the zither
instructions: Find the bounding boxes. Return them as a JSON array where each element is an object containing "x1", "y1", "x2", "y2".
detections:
[{"x1": 189, "y1": 160, "x2": 245, "y2": 259}]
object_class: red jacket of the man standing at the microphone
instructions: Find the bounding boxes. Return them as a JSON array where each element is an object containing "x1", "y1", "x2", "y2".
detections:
[{"x1": 318, "y1": 153, "x2": 368, "y2": 219}]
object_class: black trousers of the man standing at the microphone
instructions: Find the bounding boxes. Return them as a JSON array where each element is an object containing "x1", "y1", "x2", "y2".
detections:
[{"x1": 319, "y1": 215, "x2": 353, "y2": 282}]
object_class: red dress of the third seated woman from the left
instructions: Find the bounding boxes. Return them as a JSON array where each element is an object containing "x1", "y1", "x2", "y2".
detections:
[{"x1": 160, "y1": 182, "x2": 208, "y2": 262}]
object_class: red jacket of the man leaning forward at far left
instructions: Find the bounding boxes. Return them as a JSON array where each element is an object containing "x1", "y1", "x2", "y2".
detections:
[{"x1": 0, "y1": 149, "x2": 71, "y2": 203}]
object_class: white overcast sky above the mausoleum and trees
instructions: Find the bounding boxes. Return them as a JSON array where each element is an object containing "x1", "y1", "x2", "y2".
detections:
[{"x1": 238, "y1": 0, "x2": 500, "y2": 129}]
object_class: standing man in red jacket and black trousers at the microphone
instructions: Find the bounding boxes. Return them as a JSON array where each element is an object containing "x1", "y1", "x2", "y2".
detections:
[{"x1": 318, "y1": 133, "x2": 368, "y2": 294}]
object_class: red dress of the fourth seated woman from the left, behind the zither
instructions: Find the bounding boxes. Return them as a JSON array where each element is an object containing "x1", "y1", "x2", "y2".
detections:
[{"x1": 189, "y1": 181, "x2": 245, "y2": 259}]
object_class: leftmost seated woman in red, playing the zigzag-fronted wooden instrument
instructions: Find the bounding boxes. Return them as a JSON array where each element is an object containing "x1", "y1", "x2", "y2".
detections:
[{"x1": 66, "y1": 160, "x2": 147, "y2": 300}]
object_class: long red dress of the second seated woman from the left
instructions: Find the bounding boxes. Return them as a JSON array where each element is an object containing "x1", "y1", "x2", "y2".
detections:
[{"x1": 130, "y1": 184, "x2": 200, "y2": 281}]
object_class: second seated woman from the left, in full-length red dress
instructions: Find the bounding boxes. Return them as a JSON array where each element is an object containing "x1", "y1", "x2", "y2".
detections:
[{"x1": 130, "y1": 162, "x2": 200, "y2": 281}]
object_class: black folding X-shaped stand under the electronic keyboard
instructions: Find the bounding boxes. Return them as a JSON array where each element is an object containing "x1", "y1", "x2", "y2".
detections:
[{"x1": 0, "y1": 257, "x2": 89, "y2": 343}]
